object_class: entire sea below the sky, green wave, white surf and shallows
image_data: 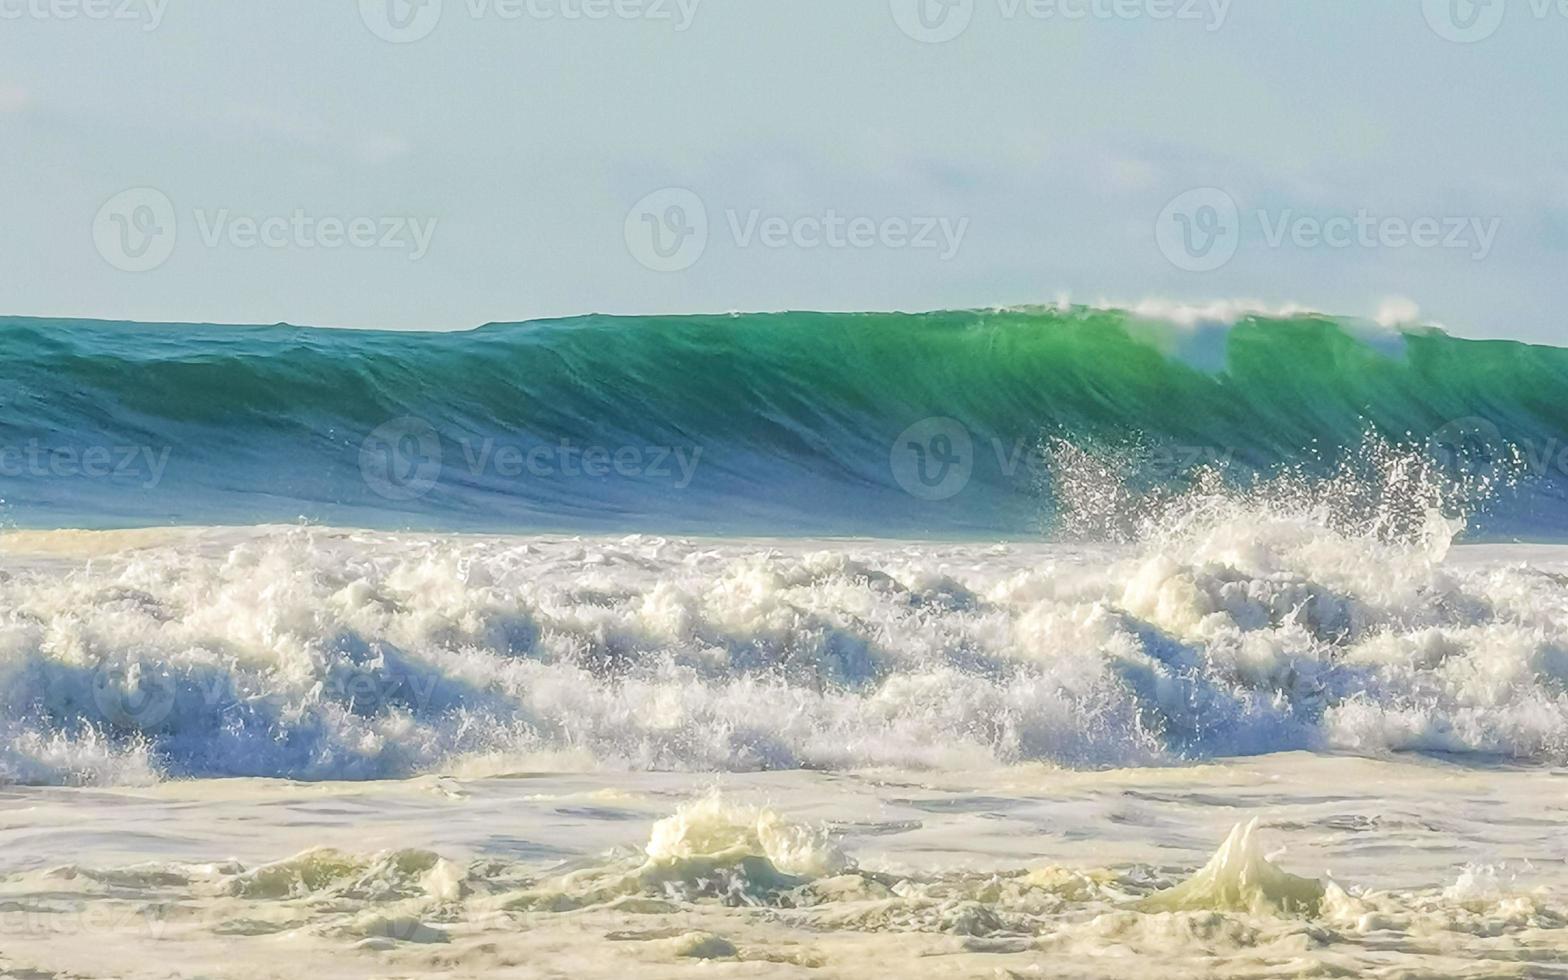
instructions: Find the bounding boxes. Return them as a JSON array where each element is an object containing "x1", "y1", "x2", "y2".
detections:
[{"x1": 0, "y1": 307, "x2": 1568, "y2": 977}]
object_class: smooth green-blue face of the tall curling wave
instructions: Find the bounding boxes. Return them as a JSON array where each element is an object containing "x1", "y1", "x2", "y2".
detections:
[{"x1": 9, "y1": 307, "x2": 1568, "y2": 538}]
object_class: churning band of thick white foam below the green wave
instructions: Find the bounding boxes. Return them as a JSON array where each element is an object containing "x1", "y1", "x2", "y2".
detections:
[{"x1": 0, "y1": 492, "x2": 1568, "y2": 782}]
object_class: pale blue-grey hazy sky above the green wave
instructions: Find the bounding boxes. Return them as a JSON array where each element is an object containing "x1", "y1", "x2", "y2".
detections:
[{"x1": 0, "y1": 0, "x2": 1568, "y2": 345}]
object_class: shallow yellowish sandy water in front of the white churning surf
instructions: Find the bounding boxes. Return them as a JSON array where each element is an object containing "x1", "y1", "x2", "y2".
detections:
[{"x1": 0, "y1": 753, "x2": 1568, "y2": 977}]
